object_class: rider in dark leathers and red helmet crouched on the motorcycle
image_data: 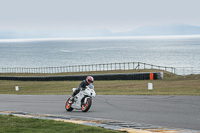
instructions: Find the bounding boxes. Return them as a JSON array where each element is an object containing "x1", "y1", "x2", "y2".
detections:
[{"x1": 70, "y1": 76, "x2": 94, "y2": 102}]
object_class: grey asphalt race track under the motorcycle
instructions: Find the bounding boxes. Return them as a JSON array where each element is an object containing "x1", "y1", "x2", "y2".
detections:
[{"x1": 0, "y1": 95, "x2": 200, "y2": 131}]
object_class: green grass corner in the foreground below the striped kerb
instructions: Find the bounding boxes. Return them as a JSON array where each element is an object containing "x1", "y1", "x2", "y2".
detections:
[{"x1": 0, "y1": 115, "x2": 117, "y2": 133}]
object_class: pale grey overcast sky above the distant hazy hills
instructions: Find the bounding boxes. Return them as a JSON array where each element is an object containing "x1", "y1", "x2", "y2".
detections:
[{"x1": 0, "y1": 0, "x2": 200, "y2": 32}]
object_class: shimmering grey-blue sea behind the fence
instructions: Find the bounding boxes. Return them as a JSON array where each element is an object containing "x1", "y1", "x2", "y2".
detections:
[{"x1": 0, "y1": 35, "x2": 200, "y2": 68}]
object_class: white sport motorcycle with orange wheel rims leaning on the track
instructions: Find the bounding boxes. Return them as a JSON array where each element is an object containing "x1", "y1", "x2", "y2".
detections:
[{"x1": 65, "y1": 84, "x2": 96, "y2": 112}]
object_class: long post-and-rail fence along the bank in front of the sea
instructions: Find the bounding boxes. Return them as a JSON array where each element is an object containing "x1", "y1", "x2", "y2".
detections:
[{"x1": 0, "y1": 62, "x2": 176, "y2": 73}]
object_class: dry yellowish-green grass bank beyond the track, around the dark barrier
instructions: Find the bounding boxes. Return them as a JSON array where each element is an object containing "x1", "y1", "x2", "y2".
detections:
[{"x1": 0, "y1": 70, "x2": 200, "y2": 95}]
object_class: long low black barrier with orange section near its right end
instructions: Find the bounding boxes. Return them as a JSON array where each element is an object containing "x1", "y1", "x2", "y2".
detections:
[{"x1": 0, "y1": 72, "x2": 163, "y2": 81}]
